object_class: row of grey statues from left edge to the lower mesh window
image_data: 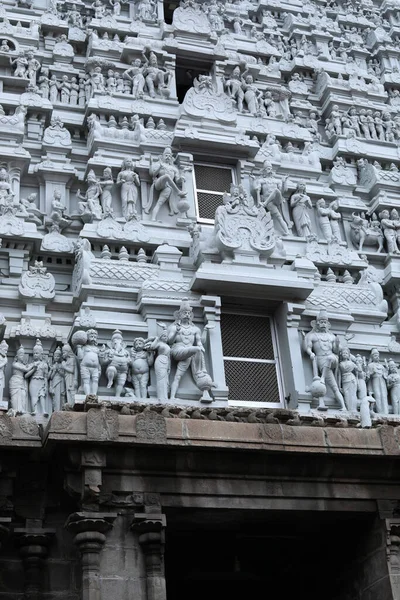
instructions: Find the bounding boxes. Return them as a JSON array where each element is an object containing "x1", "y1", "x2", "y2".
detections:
[{"x1": 0, "y1": 300, "x2": 215, "y2": 416}]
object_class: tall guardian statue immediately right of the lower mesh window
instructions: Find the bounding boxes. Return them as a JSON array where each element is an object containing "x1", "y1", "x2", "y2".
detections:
[{"x1": 304, "y1": 310, "x2": 346, "y2": 410}]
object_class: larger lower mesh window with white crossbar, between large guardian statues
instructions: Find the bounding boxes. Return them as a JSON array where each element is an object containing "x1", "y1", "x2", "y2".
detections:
[{"x1": 221, "y1": 312, "x2": 282, "y2": 407}]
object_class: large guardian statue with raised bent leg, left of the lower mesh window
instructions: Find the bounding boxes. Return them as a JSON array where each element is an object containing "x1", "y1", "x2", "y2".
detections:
[{"x1": 167, "y1": 298, "x2": 215, "y2": 400}]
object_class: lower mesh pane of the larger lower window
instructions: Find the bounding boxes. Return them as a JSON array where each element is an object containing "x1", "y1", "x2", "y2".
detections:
[{"x1": 224, "y1": 360, "x2": 280, "y2": 402}]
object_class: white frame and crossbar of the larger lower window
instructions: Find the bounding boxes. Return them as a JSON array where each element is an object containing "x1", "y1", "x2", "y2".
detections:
[{"x1": 221, "y1": 309, "x2": 285, "y2": 408}]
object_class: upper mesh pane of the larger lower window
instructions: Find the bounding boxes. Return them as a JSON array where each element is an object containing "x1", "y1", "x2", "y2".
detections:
[{"x1": 221, "y1": 313, "x2": 275, "y2": 360}]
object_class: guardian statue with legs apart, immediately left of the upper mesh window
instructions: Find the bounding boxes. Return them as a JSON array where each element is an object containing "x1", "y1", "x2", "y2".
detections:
[{"x1": 143, "y1": 147, "x2": 187, "y2": 221}]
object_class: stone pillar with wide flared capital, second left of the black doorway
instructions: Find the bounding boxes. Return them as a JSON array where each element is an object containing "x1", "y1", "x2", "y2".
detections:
[{"x1": 65, "y1": 512, "x2": 117, "y2": 600}]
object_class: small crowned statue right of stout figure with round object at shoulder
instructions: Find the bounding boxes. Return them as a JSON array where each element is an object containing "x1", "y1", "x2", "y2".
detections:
[{"x1": 99, "y1": 329, "x2": 130, "y2": 398}]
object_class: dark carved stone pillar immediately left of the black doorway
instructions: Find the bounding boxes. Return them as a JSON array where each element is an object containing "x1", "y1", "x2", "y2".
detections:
[{"x1": 131, "y1": 513, "x2": 167, "y2": 600}]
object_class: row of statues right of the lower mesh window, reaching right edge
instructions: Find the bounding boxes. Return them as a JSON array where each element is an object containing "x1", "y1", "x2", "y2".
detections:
[{"x1": 303, "y1": 310, "x2": 400, "y2": 426}]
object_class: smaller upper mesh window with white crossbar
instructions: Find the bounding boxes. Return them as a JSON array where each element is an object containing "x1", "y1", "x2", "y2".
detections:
[{"x1": 194, "y1": 163, "x2": 234, "y2": 222}]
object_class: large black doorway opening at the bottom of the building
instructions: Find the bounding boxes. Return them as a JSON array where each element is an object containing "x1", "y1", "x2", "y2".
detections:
[{"x1": 165, "y1": 511, "x2": 386, "y2": 600}]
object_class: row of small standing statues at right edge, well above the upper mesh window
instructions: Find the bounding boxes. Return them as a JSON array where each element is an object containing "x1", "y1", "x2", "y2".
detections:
[{"x1": 325, "y1": 104, "x2": 400, "y2": 142}]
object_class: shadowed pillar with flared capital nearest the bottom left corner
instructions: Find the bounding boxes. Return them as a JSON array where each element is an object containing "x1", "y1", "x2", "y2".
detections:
[{"x1": 14, "y1": 525, "x2": 55, "y2": 600}]
